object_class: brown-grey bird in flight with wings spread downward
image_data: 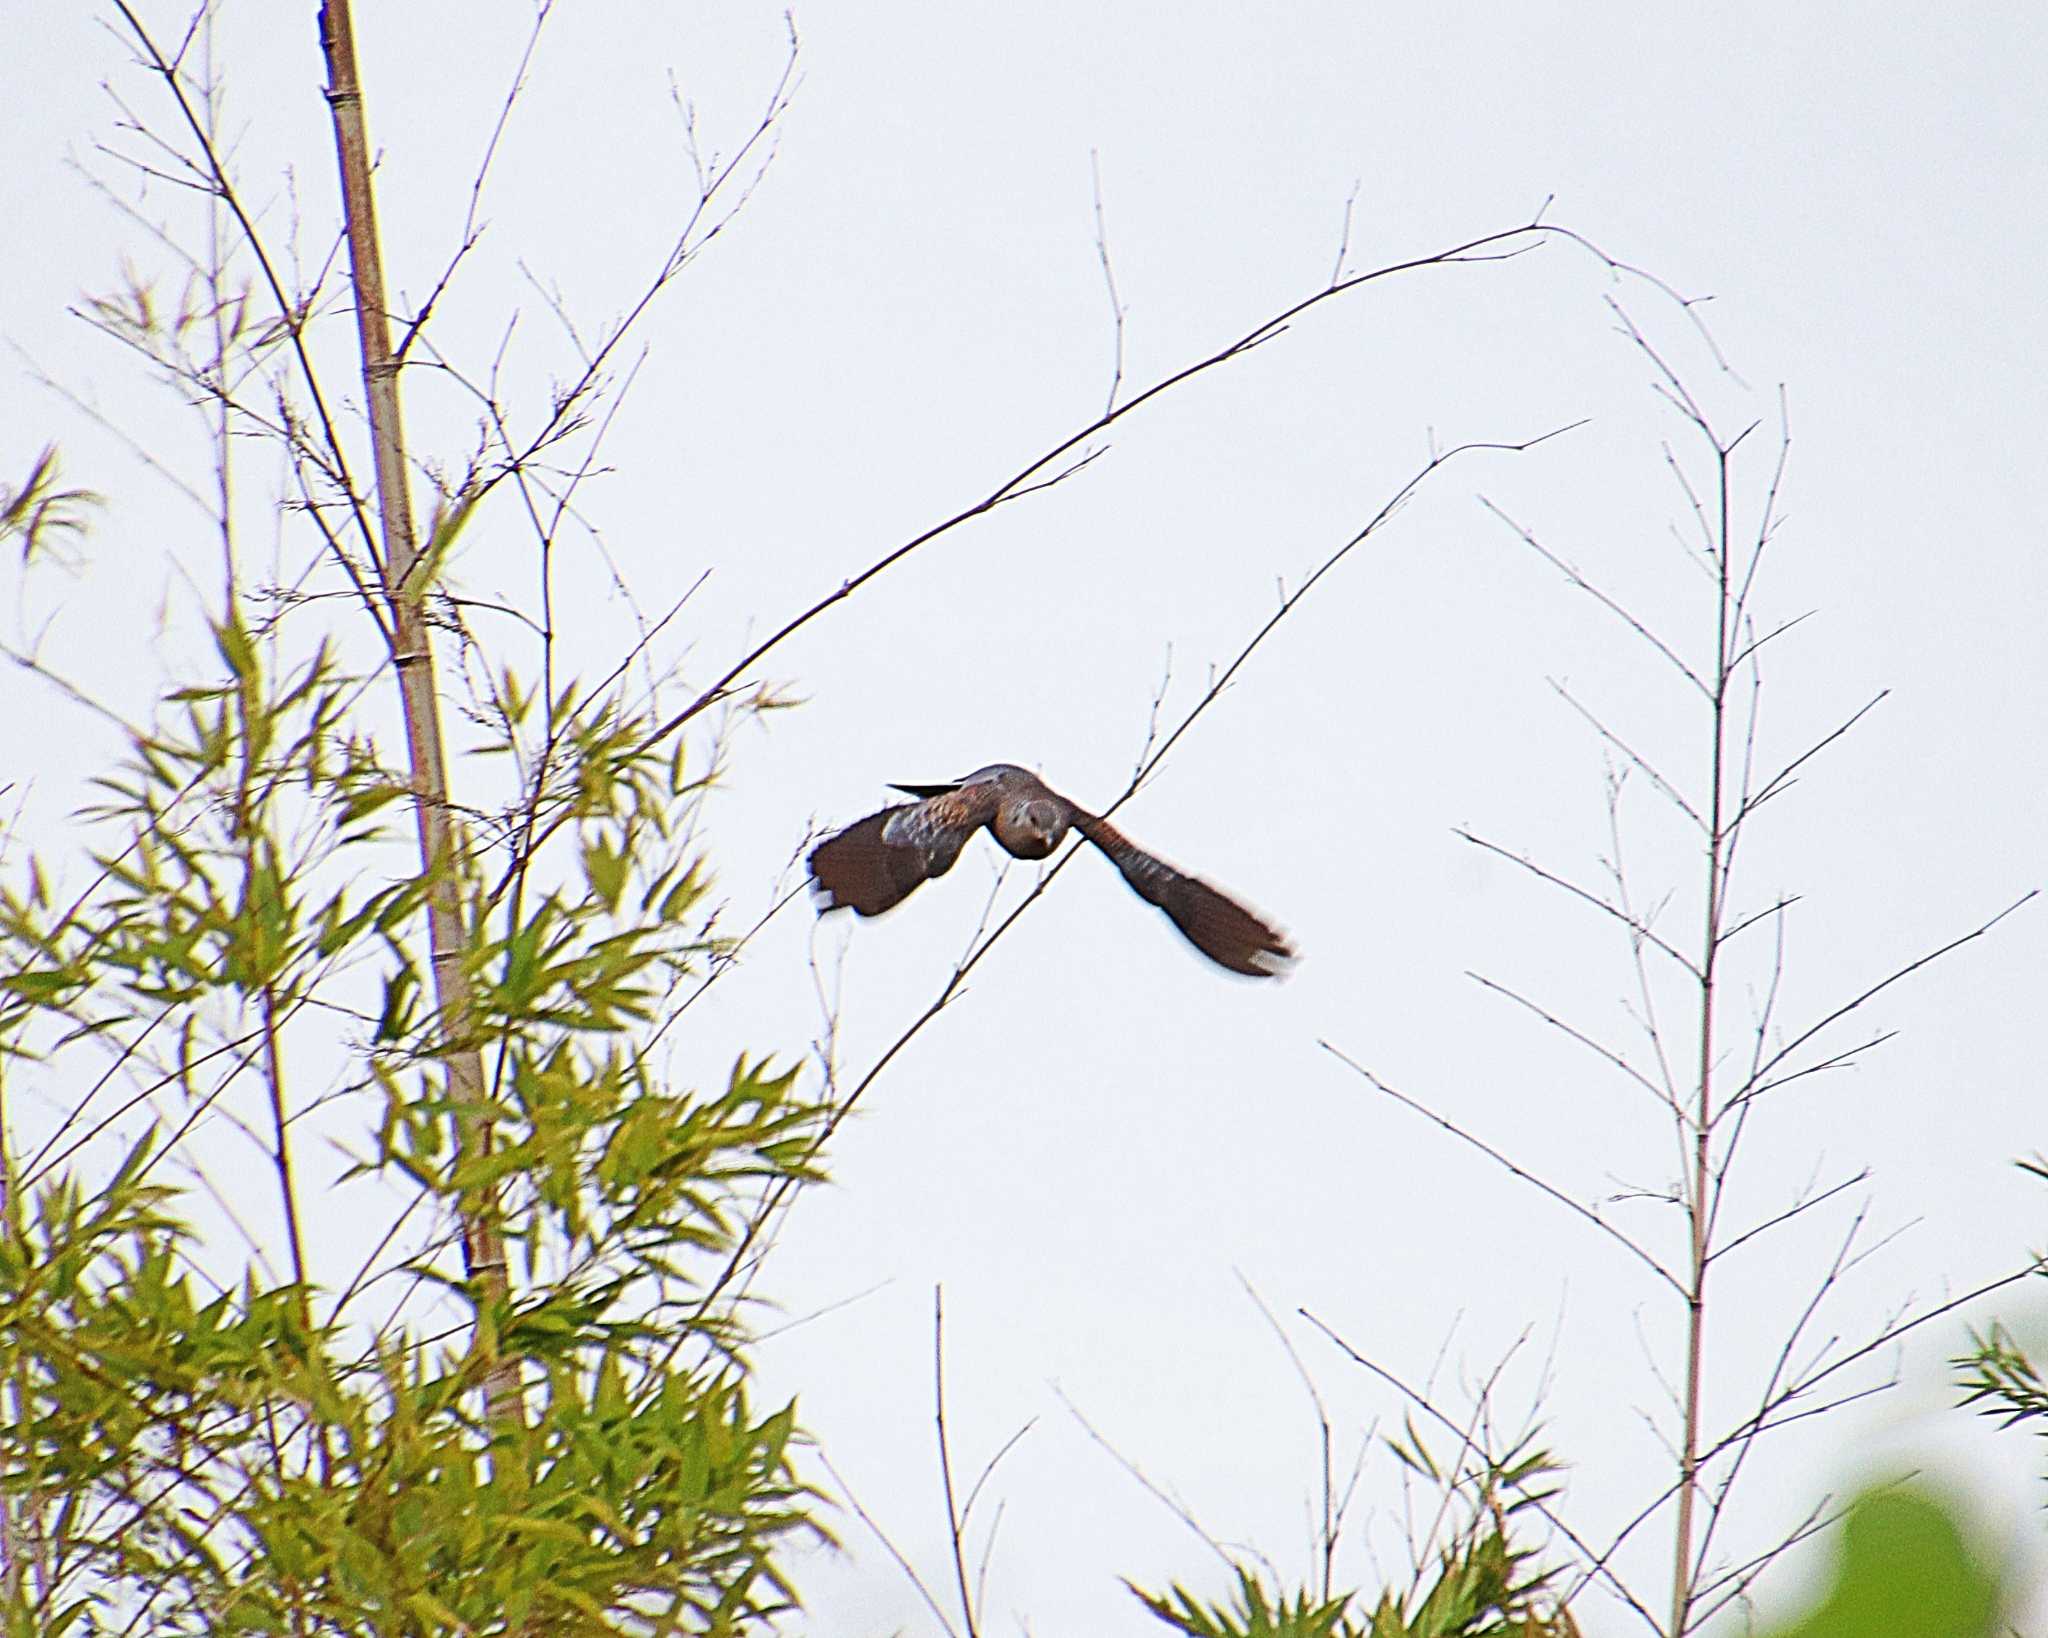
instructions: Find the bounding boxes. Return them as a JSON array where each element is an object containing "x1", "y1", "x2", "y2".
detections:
[{"x1": 811, "y1": 762, "x2": 1294, "y2": 979}]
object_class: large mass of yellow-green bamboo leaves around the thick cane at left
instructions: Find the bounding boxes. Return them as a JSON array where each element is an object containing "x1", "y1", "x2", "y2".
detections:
[{"x1": 0, "y1": 618, "x2": 819, "y2": 1634}]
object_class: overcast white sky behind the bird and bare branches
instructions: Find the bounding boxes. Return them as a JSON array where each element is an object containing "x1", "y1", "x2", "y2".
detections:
[{"x1": 0, "y1": 0, "x2": 2048, "y2": 1638}]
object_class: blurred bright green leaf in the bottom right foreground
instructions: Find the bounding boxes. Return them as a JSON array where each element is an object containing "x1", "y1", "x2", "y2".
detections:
[{"x1": 1774, "y1": 1489, "x2": 2009, "y2": 1638}]
